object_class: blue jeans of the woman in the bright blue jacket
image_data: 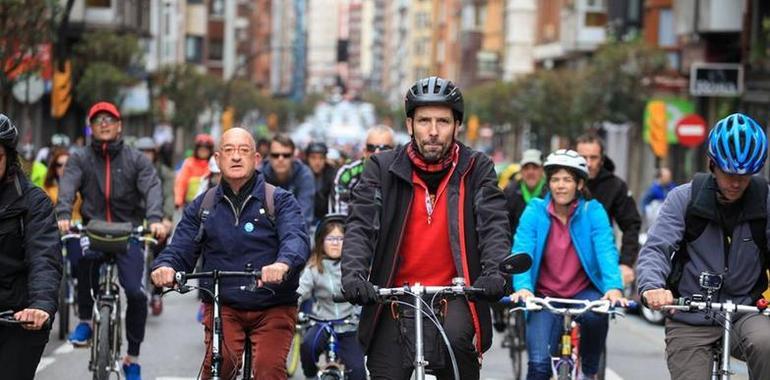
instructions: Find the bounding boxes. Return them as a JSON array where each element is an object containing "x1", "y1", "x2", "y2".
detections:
[{"x1": 527, "y1": 287, "x2": 609, "y2": 380}]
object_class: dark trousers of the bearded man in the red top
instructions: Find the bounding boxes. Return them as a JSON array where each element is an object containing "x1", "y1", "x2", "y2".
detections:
[{"x1": 366, "y1": 298, "x2": 479, "y2": 380}]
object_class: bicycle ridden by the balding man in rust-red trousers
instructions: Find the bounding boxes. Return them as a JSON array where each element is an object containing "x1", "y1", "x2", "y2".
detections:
[{"x1": 170, "y1": 264, "x2": 262, "y2": 380}]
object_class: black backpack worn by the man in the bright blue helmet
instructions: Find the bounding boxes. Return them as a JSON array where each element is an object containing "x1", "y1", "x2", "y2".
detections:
[{"x1": 666, "y1": 173, "x2": 770, "y2": 299}]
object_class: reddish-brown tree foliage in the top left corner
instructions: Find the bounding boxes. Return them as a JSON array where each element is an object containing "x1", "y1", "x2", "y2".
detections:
[{"x1": 0, "y1": 0, "x2": 59, "y2": 109}]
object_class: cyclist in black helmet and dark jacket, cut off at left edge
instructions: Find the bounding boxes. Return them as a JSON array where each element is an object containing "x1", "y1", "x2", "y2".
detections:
[{"x1": 0, "y1": 114, "x2": 62, "y2": 379}]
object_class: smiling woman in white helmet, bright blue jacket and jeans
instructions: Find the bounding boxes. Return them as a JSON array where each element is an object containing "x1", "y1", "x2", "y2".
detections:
[{"x1": 512, "y1": 149, "x2": 627, "y2": 379}]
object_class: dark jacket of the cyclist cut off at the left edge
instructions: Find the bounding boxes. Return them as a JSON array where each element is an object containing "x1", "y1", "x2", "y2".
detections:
[{"x1": 0, "y1": 175, "x2": 62, "y2": 318}]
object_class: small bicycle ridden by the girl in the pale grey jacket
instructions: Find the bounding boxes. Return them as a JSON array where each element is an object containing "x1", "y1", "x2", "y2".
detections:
[{"x1": 299, "y1": 313, "x2": 358, "y2": 380}]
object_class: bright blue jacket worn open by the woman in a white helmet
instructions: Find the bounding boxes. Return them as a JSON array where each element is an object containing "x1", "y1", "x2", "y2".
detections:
[{"x1": 511, "y1": 194, "x2": 623, "y2": 293}]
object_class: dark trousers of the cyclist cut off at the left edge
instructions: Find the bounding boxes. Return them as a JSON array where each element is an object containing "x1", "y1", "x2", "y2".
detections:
[{"x1": 0, "y1": 327, "x2": 51, "y2": 380}]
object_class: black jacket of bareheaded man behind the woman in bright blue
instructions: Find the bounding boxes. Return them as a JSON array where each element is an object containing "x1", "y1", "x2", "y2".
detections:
[{"x1": 588, "y1": 157, "x2": 642, "y2": 268}]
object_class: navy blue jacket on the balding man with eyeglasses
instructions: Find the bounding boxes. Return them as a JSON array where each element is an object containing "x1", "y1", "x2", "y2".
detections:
[{"x1": 153, "y1": 172, "x2": 310, "y2": 310}]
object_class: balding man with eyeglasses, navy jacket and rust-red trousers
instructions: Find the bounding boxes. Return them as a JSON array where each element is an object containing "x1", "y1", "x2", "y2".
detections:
[{"x1": 152, "y1": 128, "x2": 310, "y2": 379}]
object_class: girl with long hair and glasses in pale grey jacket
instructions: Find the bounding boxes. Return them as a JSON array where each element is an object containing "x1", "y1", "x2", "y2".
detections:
[{"x1": 297, "y1": 214, "x2": 366, "y2": 380}]
